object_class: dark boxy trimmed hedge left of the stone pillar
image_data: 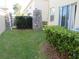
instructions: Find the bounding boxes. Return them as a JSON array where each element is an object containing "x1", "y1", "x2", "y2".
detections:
[{"x1": 15, "y1": 16, "x2": 32, "y2": 29}]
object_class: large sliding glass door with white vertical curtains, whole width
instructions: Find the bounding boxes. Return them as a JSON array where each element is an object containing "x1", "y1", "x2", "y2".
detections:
[{"x1": 59, "y1": 4, "x2": 77, "y2": 29}]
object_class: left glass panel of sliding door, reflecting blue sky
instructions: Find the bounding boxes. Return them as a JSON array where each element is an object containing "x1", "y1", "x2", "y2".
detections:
[{"x1": 59, "y1": 6, "x2": 69, "y2": 28}]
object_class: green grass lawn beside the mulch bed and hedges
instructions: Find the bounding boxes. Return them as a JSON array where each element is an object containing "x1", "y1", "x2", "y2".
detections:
[{"x1": 0, "y1": 30, "x2": 46, "y2": 59}]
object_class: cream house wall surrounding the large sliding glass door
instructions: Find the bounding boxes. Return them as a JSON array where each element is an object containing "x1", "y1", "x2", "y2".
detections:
[{"x1": 49, "y1": 0, "x2": 79, "y2": 27}]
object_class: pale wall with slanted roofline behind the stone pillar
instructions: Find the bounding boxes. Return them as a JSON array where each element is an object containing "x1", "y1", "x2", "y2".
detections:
[{"x1": 25, "y1": 0, "x2": 49, "y2": 21}]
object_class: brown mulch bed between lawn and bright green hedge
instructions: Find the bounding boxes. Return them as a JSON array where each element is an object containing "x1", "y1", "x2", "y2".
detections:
[{"x1": 42, "y1": 43, "x2": 68, "y2": 59}]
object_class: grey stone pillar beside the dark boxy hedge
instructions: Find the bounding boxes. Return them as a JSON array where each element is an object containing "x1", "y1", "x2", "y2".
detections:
[{"x1": 33, "y1": 9, "x2": 42, "y2": 31}]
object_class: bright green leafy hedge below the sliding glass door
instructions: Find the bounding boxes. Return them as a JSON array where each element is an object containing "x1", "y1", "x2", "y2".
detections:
[{"x1": 45, "y1": 26, "x2": 79, "y2": 59}]
